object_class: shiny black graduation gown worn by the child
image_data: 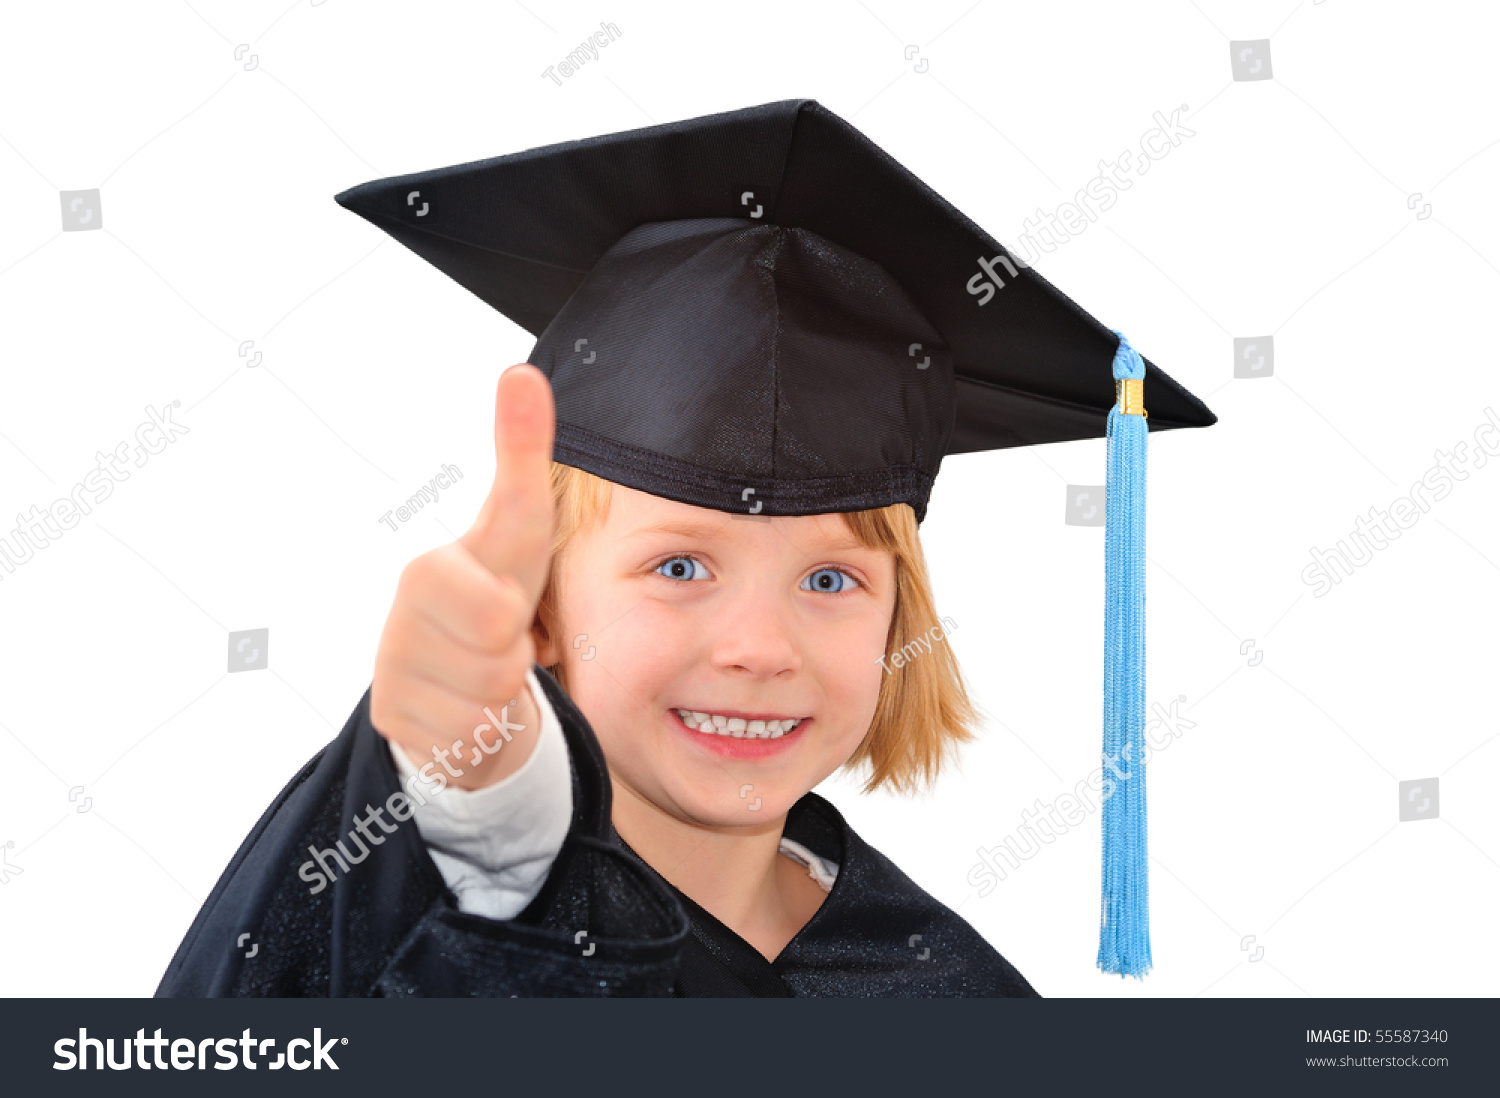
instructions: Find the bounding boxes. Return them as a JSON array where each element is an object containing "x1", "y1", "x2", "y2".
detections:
[{"x1": 156, "y1": 668, "x2": 1037, "y2": 998}]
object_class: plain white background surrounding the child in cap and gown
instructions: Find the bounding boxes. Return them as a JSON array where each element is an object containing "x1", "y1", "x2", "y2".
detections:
[{"x1": 0, "y1": 0, "x2": 1500, "y2": 996}]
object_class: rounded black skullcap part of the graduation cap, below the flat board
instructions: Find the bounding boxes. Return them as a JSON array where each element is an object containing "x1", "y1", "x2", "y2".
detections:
[{"x1": 531, "y1": 218, "x2": 954, "y2": 518}]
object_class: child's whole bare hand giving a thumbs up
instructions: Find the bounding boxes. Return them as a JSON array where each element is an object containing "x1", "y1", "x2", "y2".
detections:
[{"x1": 371, "y1": 365, "x2": 555, "y2": 789}]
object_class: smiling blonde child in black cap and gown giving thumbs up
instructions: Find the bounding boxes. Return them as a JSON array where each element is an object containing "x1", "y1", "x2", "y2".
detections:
[{"x1": 158, "y1": 101, "x2": 1214, "y2": 996}]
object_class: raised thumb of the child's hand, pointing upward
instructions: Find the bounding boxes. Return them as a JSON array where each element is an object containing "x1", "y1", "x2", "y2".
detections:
[{"x1": 459, "y1": 363, "x2": 557, "y2": 606}]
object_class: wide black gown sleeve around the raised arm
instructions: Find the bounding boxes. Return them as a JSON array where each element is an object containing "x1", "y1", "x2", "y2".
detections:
[{"x1": 156, "y1": 668, "x2": 689, "y2": 998}]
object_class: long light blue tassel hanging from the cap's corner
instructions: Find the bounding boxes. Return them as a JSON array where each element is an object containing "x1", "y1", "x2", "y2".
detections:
[{"x1": 1098, "y1": 332, "x2": 1151, "y2": 978}]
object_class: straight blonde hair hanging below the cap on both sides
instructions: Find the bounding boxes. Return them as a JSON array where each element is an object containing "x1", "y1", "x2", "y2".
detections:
[{"x1": 539, "y1": 462, "x2": 978, "y2": 794}]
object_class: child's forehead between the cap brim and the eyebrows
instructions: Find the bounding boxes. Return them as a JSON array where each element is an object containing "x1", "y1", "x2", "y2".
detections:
[{"x1": 602, "y1": 485, "x2": 864, "y2": 551}]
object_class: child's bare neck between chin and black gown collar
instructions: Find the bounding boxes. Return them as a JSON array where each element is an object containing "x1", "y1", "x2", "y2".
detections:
[{"x1": 612, "y1": 780, "x2": 807, "y2": 960}]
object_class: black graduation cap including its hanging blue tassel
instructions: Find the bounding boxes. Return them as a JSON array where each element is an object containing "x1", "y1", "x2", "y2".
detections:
[{"x1": 338, "y1": 99, "x2": 1215, "y2": 975}]
